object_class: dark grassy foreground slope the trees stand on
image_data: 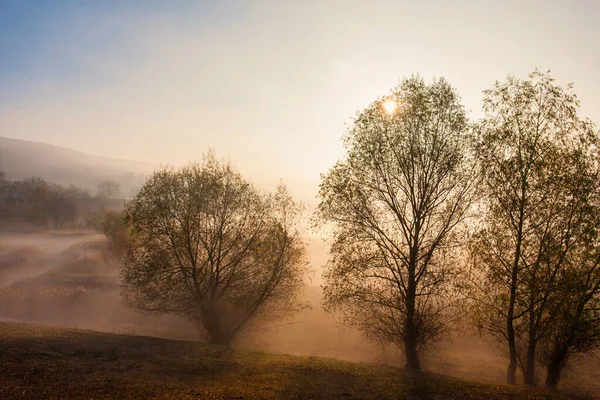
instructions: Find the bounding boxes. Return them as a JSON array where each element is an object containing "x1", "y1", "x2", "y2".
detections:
[{"x1": 0, "y1": 323, "x2": 584, "y2": 400}]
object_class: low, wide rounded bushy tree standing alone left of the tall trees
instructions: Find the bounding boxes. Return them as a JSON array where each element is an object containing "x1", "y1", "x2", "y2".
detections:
[{"x1": 122, "y1": 153, "x2": 307, "y2": 344}]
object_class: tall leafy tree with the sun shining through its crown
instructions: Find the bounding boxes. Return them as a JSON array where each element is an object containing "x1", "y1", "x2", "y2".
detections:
[{"x1": 317, "y1": 77, "x2": 474, "y2": 370}]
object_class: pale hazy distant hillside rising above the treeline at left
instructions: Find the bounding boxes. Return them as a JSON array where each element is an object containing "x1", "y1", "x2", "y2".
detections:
[{"x1": 0, "y1": 137, "x2": 158, "y2": 194}]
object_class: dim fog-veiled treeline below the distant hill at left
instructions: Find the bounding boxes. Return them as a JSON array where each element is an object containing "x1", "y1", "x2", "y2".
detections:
[{"x1": 0, "y1": 173, "x2": 124, "y2": 230}]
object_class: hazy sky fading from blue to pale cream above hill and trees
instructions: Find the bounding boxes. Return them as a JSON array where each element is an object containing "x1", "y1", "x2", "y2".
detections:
[{"x1": 0, "y1": 0, "x2": 600, "y2": 200}]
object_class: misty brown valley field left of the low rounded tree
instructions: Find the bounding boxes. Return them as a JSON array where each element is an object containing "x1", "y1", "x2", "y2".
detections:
[{"x1": 0, "y1": 228, "x2": 197, "y2": 339}]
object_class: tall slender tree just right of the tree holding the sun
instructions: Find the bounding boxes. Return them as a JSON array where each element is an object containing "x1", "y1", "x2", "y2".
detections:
[{"x1": 472, "y1": 71, "x2": 589, "y2": 385}]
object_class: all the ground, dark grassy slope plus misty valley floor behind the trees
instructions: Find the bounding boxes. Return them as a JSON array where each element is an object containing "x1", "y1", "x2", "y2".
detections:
[{"x1": 0, "y1": 232, "x2": 600, "y2": 399}]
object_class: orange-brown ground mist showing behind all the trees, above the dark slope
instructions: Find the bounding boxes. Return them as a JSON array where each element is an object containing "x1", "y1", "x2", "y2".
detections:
[{"x1": 0, "y1": 231, "x2": 600, "y2": 396}]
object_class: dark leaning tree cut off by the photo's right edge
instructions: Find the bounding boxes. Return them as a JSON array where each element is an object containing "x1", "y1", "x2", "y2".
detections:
[{"x1": 539, "y1": 133, "x2": 600, "y2": 390}]
